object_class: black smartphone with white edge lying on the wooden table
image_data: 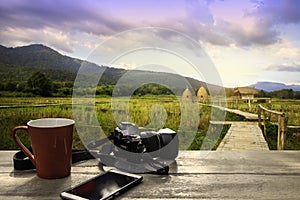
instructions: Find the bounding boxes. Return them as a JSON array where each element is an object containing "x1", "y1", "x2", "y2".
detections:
[{"x1": 60, "y1": 170, "x2": 143, "y2": 200}]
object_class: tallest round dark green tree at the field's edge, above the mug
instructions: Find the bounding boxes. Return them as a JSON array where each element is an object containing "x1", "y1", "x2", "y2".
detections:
[{"x1": 27, "y1": 71, "x2": 52, "y2": 97}]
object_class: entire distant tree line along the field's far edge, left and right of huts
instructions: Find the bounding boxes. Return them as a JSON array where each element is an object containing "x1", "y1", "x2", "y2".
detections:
[{"x1": 0, "y1": 71, "x2": 300, "y2": 99}]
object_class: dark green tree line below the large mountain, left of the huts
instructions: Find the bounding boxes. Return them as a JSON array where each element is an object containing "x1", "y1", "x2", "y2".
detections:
[{"x1": 0, "y1": 71, "x2": 173, "y2": 97}]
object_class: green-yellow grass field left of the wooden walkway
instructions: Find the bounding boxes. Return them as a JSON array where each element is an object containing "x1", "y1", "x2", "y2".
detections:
[{"x1": 0, "y1": 96, "x2": 227, "y2": 150}]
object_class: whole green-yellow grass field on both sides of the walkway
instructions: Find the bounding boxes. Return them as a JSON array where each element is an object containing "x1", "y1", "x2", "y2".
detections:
[{"x1": 0, "y1": 96, "x2": 300, "y2": 150}]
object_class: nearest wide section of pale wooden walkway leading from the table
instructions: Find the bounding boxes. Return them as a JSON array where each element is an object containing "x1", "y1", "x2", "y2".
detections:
[{"x1": 216, "y1": 122, "x2": 269, "y2": 151}]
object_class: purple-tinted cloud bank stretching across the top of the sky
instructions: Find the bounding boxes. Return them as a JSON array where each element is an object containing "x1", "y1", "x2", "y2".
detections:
[{"x1": 0, "y1": 0, "x2": 300, "y2": 51}]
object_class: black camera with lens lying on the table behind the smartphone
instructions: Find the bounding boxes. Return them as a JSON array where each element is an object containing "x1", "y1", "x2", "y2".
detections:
[{"x1": 86, "y1": 122, "x2": 179, "y2": 174}]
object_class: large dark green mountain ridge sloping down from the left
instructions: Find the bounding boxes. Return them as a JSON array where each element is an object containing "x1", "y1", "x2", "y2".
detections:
[{"x1": 0, "y1": 44, "x2": 222, "y2": 93}]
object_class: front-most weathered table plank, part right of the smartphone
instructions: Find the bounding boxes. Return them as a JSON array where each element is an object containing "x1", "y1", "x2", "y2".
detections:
[{"x1": 122, "y1": 174, "x2": 300, "y2": 200}]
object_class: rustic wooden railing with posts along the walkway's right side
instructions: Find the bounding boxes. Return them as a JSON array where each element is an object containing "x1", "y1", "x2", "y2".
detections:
[{"x1": 257, "y1": 104, "x2": 288, "y2": 150}]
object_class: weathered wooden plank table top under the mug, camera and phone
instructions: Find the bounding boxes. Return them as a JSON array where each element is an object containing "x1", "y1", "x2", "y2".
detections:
[{"x1": 0, "y1": 151, "x2": 300, "y2": 200}]
